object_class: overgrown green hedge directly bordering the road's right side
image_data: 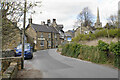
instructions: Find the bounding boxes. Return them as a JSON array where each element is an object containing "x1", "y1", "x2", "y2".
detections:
[{"x1": 62, "y1": 40, "x2": 120, "y2": 68}]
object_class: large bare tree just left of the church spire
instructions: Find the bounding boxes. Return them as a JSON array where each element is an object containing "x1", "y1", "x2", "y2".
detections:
[{"x1": 77, "y1": 7, "x2": 94, "y2": 27}]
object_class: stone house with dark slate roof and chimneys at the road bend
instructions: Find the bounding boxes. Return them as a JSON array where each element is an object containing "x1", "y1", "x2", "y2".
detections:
[{"x1": 25, "y1": 18, "x2": 64, "y2": 50}]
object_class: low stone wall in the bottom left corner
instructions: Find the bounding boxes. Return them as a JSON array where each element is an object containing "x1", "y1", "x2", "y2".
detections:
[{"x1": 0, "y1": 57, "x2": 22, "y2": 80}]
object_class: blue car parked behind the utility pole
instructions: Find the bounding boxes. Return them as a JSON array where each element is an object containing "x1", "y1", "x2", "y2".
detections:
[{"x1": 15, "y1": 43, "x2": 33, "y2": 59}]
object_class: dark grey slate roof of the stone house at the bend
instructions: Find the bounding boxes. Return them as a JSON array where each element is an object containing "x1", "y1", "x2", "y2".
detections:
[{"x1": 31, "y1": 24, "x2": 59, "y2": 33}]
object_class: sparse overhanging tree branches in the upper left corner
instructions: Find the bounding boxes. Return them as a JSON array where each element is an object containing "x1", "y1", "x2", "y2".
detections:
[{"x1": 1, "y1": 1, "x2": 41, "y2": 22}]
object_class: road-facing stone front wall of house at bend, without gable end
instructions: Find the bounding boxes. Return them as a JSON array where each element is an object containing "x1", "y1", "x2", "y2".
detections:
[{"x1": 36, "y1": 32, "x2": 60, "y2": 50}]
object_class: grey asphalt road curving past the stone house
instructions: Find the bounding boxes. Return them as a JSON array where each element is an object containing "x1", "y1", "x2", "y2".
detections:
[{"x1": 17, "y1": 49, "x2": 118, "y2": 78}]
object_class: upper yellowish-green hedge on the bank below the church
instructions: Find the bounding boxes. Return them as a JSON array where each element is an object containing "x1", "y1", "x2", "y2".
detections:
[{"x1": 72, "y1": 29, "x2": 120, "y2": 42}]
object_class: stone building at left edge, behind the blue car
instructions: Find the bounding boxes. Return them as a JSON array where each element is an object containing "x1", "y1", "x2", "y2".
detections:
[{"x1": 2, "y1": 19, "x2": 22, "y2": 51}]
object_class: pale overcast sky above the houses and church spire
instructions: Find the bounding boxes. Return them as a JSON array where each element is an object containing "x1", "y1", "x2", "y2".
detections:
[{"x1": 24, "y1": 0, "x2": 119, "y2": 31}]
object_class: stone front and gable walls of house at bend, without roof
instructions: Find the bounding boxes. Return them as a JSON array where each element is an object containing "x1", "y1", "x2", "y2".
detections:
[{"x1": 26, "y1": 26, "x2": 61, "y2": 50}]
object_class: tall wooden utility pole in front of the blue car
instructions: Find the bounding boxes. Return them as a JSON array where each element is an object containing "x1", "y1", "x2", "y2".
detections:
[{"x1": 21, "y1": 0, "x2": 27, "y2": 69}]
